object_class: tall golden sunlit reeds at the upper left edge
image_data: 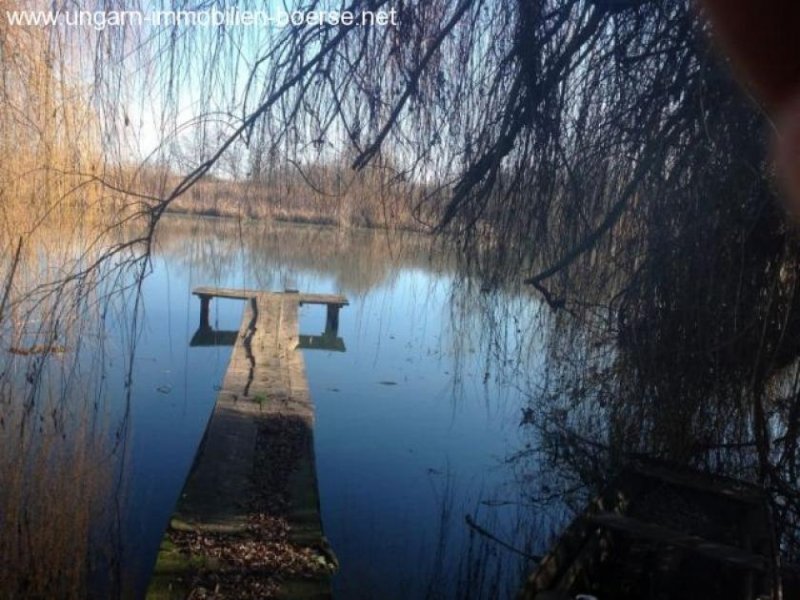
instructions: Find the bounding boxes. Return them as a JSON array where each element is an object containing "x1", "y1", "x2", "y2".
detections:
[{"x1": 0, "y1": 0, "x2": 147, "y2": 310}]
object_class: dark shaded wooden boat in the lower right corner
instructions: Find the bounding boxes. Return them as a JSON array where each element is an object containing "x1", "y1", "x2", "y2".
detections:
[{"x1": 519, "y1": 461, "x2": 788, "y2": 600}]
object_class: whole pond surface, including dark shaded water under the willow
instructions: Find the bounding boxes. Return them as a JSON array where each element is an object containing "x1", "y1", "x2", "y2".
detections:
[{"x1": 0, "y1": 217, "x2": 800, "y2": 598}]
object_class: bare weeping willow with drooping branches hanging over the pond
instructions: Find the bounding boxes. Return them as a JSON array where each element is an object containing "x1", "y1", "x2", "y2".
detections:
[{"x1": 4, "y1": 0, "x2": 800, "y2": 584}]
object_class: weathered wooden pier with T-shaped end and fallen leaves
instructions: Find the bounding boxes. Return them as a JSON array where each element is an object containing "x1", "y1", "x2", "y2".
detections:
[{"x1": 148, "y1": 287, "x2": 348, "y2": 598}]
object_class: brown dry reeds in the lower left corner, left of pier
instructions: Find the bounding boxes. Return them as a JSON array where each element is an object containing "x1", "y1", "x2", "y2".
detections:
[{"x1": 0, "y1": 372, "x2": 113, "y2": 598}]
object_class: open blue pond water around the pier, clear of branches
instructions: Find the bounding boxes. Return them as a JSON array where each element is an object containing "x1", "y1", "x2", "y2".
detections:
[{"x1": 100, "y1": 217, "x2": 557, "y2": 598}]
